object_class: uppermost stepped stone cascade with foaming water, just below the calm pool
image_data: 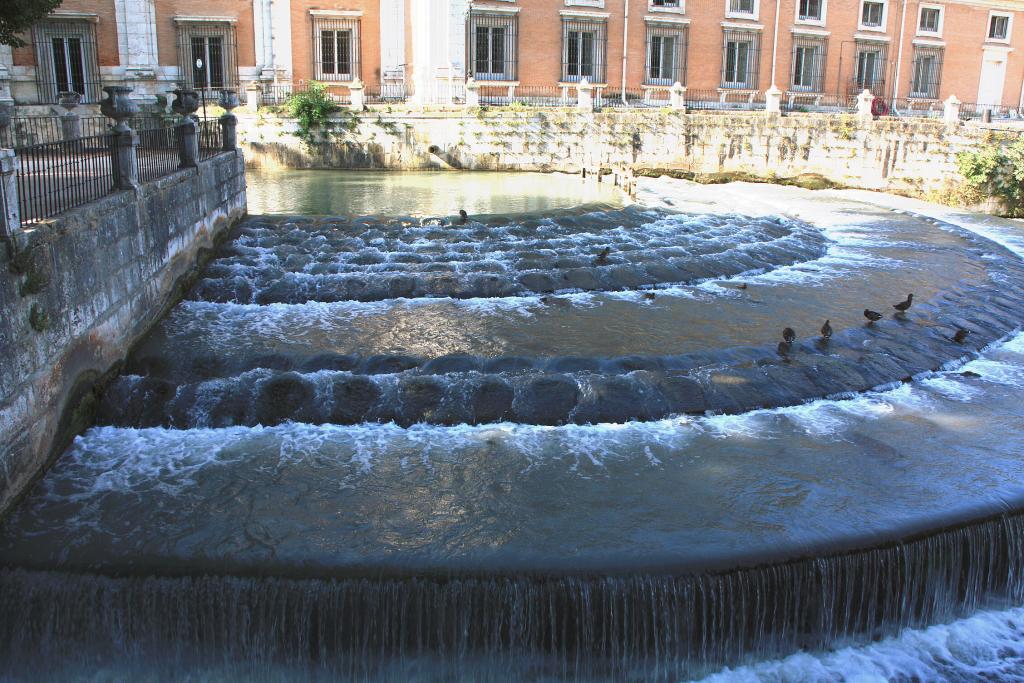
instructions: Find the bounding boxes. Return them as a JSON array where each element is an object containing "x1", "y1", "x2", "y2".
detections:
[{"x1": 194, "y1": 210, "x2": 827, "y2": 304}]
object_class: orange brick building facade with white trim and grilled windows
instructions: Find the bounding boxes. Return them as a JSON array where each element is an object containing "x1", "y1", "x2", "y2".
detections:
[{"x1": 0, "y1": 0, "x2": 1024, "y2": 108}]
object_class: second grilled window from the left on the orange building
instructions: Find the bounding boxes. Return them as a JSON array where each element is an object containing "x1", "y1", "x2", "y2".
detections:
[{"x1": 178, "y1": 22, "x2": 239, "y2": 90}]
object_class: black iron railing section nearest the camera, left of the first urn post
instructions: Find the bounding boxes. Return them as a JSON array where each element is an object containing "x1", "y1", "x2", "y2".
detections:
[{"x1": 17, "y1": 133, "x2": 117, "y2": 225}]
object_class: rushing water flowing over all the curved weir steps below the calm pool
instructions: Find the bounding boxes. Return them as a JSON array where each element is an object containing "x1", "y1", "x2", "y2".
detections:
[{"x1": 0, "y1": 176, "x2": 1024, "y2": 681}]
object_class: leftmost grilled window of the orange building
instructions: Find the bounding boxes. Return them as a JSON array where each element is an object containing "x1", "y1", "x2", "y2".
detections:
[{"x1": 32, "y1": 22, "x2": 100, "y2": 103}]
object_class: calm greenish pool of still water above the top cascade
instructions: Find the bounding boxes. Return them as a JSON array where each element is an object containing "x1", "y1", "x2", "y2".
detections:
[{"x1": 246, "y1": 169, "x2": 625, "y2": 216}]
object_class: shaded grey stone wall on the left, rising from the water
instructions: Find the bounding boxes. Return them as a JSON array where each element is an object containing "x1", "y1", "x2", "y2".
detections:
[{"x1": 0, "y1": 149, "x2": 246, "y2": 514}]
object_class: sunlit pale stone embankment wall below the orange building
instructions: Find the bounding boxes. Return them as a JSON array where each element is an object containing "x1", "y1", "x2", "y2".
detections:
[{"x1": 240, "y1": 110, "x2": 1011, "y2": 196}]
